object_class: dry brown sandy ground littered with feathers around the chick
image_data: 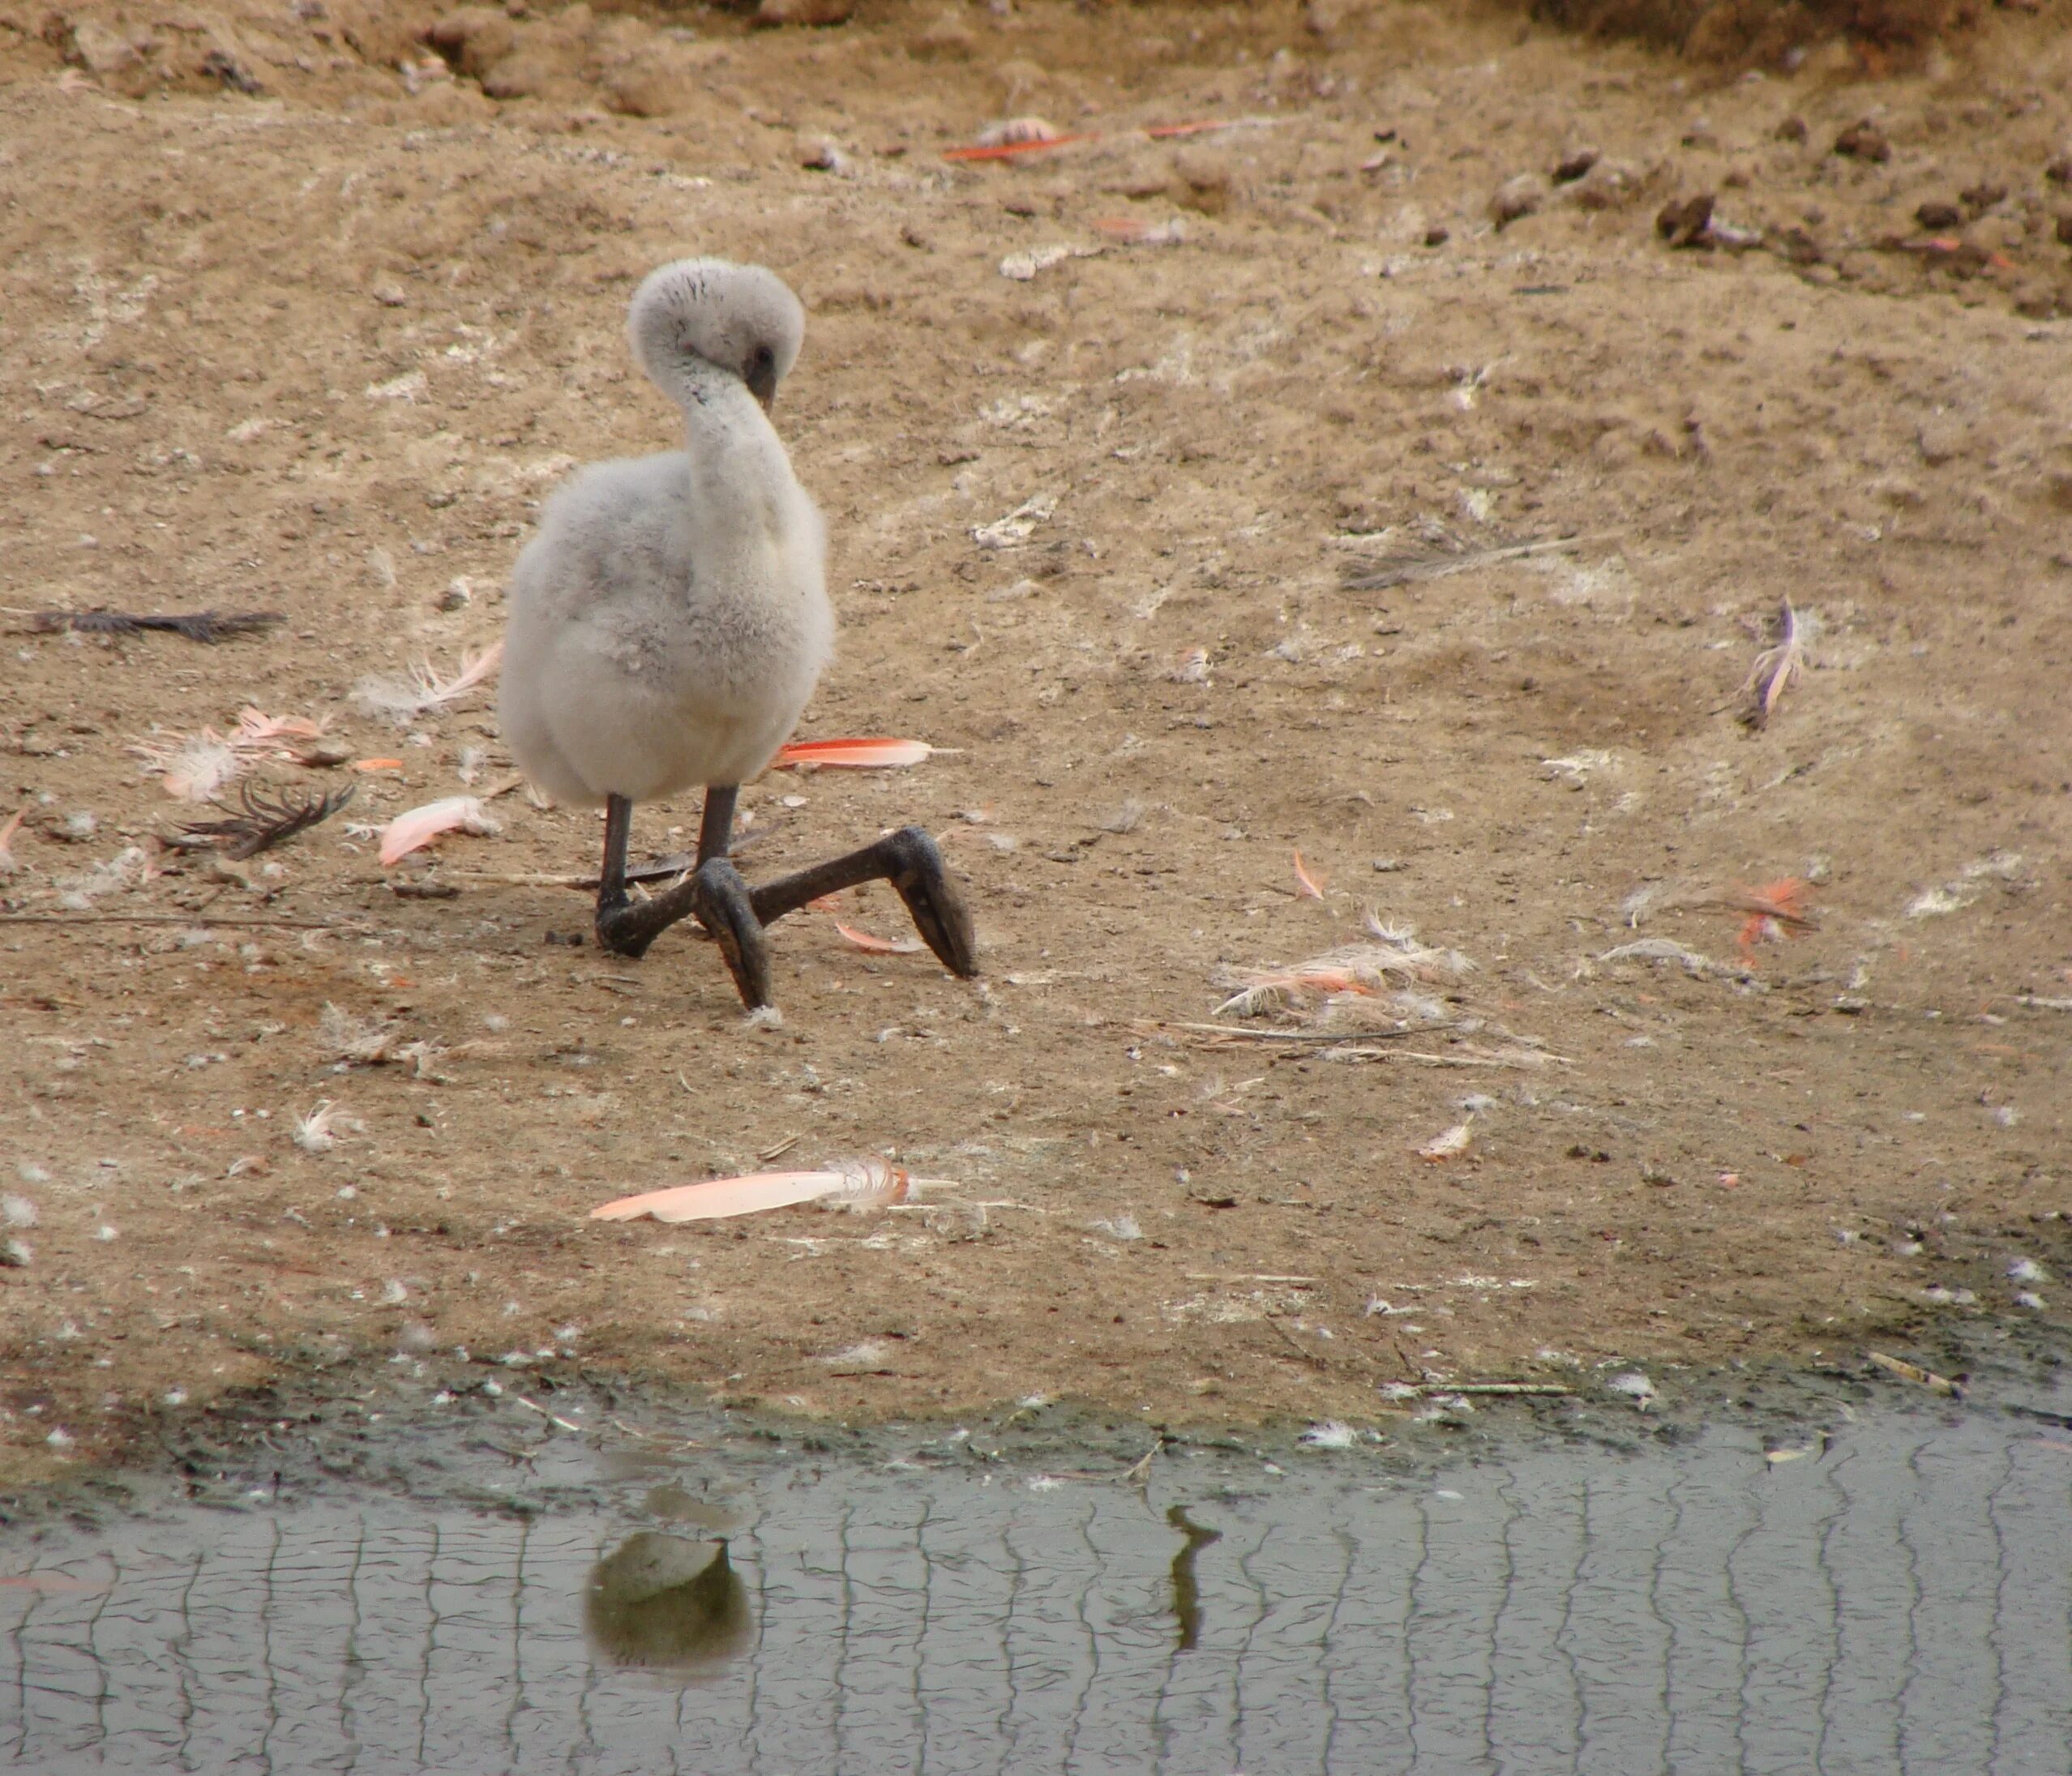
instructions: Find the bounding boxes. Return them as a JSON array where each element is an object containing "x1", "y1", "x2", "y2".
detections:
[{"x1": 0, "y1": 4, "x2": 2072, "y2": 1478}]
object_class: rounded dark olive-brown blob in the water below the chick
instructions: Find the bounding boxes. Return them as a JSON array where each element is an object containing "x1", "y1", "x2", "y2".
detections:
[{"x1": 582, "y1": 1530, "x2": 752, "y2": 1671}]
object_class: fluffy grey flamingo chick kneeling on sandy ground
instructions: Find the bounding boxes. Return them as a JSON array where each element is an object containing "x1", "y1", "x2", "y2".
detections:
[{"x1": 502, "y1": 259, "x2": 978, "y2": 1008}]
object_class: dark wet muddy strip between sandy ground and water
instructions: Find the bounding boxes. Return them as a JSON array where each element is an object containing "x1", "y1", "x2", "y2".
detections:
[{"x1": 0, "y1": 1325, "x2": 2072, "y2": 1535}]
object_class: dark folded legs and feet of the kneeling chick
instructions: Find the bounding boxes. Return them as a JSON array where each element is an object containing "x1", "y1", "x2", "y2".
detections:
[{"x1": 597, "y1": 785, "x2": 978, "y2": 1008}]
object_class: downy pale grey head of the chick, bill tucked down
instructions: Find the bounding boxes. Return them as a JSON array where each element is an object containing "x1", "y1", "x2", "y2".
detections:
[{"x1": 626, "y1": 259, "x2": 806, "y2": 409}]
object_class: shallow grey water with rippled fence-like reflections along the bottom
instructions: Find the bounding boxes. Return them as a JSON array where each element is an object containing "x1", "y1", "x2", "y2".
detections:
[{"x1": 0, "y1": 1397, "x2": 2072, "y2": 1776}]
